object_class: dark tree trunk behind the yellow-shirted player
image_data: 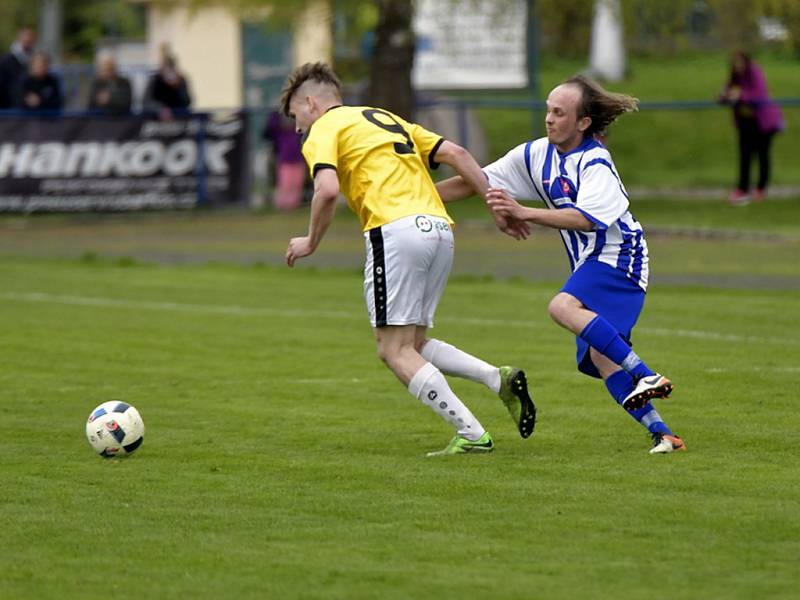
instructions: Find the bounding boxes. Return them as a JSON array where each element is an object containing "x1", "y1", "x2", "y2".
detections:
[{"x1": 365, "y1": 0, "x2": 415, "y2": 119}]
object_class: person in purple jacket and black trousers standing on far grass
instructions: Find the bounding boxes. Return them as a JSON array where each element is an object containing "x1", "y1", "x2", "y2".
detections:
[{"x1": 720, "y1": 52, "x2": 783, "y2": 206}]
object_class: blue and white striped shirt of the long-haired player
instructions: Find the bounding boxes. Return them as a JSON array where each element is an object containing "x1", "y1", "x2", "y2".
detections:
[{"x1": 483, "y1": 138, "x2": 649, "y2": 290}]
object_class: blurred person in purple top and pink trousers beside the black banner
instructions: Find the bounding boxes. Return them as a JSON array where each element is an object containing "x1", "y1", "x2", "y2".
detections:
[{"x1": 262, "y1": 111, "x2": 307, "y2": 210}]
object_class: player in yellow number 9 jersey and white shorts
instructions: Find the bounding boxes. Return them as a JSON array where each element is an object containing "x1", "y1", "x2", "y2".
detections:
[{"x1": 281, "y1": 63, "x2": 536, "y2": 456}]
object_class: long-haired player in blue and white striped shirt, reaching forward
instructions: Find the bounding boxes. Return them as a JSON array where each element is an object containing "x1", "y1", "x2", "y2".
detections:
[{"x1": 437, "y1": 76, "x2": 686, "y2": 454}]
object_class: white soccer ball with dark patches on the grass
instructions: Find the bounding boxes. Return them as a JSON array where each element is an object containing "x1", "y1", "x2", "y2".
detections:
[{"x1": 86, "y1": 400, "x2": 144, "y2": 458}]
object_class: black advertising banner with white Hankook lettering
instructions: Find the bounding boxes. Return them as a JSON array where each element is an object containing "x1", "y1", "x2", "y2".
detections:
[{"x1": 0, "y1": 113, "x2": 249, "y2": 212}]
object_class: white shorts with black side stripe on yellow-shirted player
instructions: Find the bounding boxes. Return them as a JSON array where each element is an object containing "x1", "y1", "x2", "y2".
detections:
[{"x1": 364, "y1": 215, "x2": 453, "y2": 327}]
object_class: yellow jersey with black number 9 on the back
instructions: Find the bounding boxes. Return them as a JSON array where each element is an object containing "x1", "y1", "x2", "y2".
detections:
[{"x1": 303, "y1": 106, "x2": 453, "y2": 231}]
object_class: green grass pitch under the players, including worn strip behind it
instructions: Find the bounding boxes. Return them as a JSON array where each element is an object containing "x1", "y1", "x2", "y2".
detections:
[{"x1": 0, "y1": 202, "x2": 800, "y2": 599}]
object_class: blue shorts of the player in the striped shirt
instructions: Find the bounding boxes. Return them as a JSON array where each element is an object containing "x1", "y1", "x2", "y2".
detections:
[{"x1": 561, "y1": 260, "x2": 645, "y2": 377}]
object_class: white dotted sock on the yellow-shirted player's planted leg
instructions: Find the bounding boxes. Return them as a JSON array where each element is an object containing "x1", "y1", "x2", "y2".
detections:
[{"x1": 408, "y1": 363, "x2": 486, "y2": 442}]
